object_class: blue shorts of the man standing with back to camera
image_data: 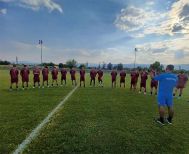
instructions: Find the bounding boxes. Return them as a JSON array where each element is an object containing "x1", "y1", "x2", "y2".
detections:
[{"x1": 158, "y1": 95, "x2": 173, "y2": 107}]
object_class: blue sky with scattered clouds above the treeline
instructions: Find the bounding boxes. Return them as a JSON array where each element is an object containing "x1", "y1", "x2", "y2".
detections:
[{"x1": 0, "y1": 0, "x2": 189, "y2": 64}]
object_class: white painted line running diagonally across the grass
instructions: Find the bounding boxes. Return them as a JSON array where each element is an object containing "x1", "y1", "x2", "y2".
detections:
[{"x1": 13, "y1": 86, "x2": 78, "y2": 154}]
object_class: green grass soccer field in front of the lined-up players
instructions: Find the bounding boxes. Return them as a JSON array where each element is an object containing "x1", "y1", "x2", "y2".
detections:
[{"x1": 0, "y1": 70, "x2": 189, "y2": 154}]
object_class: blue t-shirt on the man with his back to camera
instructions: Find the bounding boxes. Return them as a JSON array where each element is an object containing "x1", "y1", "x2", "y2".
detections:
[{"x1": 154, "y1": 73, "x2": 178, "y2": 96}]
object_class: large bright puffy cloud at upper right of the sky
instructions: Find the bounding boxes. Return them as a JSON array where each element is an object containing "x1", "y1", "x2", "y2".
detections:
[{"x1": 115, "y1": 0, "x2": 189, "y2": 37}]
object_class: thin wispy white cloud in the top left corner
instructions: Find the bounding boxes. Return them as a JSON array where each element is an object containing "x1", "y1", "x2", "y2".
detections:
[{"x1": 0, "y1": 0, "x2": 63, "y2": 13}]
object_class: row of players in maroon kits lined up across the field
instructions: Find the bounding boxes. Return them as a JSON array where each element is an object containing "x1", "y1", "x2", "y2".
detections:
[{"x1": 10, "y1": 65, "x2": 187, "y2": 96}]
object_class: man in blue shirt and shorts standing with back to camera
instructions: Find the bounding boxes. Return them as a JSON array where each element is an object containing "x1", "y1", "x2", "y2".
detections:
[{"x1": 153, "y1": 65, "x2": 178, "y2": 125}]
